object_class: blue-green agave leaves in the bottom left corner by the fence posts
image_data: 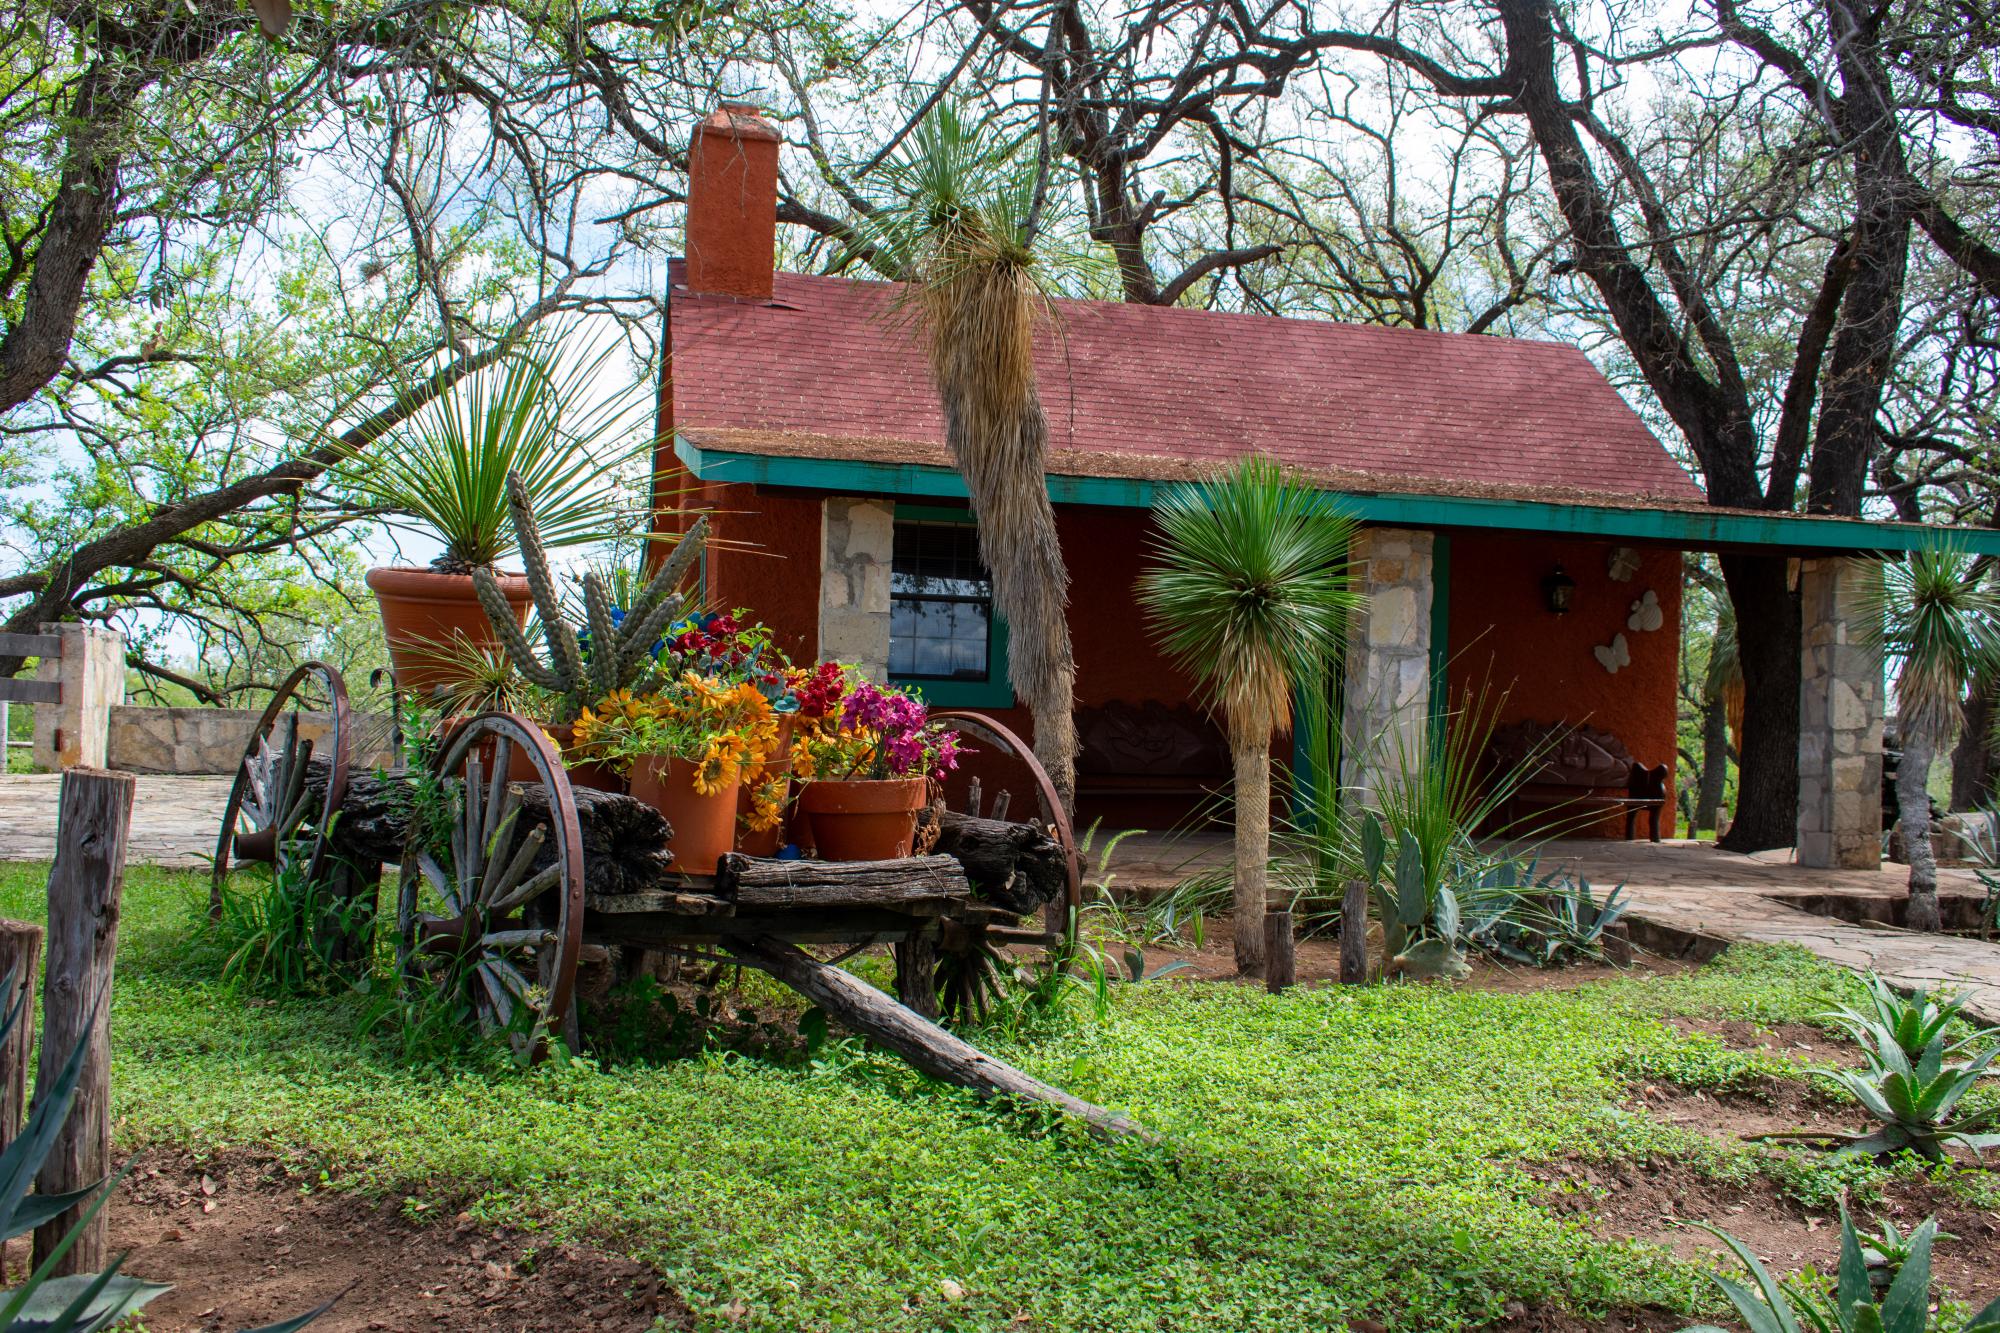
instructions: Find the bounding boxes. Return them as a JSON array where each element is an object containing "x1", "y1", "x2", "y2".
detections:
[{"x1": 0, "y1": 971, "x2": 332, "y2": 1333}]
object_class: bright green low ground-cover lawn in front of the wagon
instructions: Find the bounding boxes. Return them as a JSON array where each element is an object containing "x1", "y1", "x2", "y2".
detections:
[{"x1": 0, "y1": 865, "x2": 1960, "y2": 1331}]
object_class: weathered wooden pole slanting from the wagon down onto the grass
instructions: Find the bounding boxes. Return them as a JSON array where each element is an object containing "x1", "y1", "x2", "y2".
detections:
[{"x1": 726, "y1": 935, "x2": 1154, "y2": 1139}]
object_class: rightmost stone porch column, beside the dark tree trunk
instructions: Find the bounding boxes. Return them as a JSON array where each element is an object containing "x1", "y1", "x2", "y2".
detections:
[{"x1": 1798, "y1": 556, "x2": 1884, "y2": 871}]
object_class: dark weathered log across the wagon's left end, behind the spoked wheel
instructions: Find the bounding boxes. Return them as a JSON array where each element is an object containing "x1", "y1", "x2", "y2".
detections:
[{"x1": 306, "y1": 761, "x2": 680, "y2": 893}]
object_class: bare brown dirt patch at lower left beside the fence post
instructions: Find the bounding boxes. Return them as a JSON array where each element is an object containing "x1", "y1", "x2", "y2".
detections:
[{"x1": 94, "y1": 1151, "x2": 692, "y2": 1333}]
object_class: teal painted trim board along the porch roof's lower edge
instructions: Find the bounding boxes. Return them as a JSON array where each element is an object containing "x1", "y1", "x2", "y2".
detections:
[{"x1": 674, "y1": 428, "x2": 2000, "y2": 554}]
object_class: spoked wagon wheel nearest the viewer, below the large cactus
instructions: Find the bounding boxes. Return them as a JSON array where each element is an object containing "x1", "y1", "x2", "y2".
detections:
[{"x1": 396, "y1": 713, "x2": 584, "y2": 1059}]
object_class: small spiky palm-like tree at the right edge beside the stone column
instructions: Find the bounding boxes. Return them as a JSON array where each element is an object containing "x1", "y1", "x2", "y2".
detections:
[{"x1": 1880, "y1": 542, "x2": 2000, "y2": 931}]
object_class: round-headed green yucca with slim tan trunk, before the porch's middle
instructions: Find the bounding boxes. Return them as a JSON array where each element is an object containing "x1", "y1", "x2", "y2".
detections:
[{"x1": 1138, "y1": 456, "x2": 1362, "y2": 973}]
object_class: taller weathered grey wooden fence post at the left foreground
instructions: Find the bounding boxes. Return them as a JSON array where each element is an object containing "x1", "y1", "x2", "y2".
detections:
[{"x1": 34, "y1": 769, "x2": 134, "y2": 1275}]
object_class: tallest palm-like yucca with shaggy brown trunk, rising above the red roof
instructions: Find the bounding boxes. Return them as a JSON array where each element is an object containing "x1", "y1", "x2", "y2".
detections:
[{"x1": 866, "y1": 100, "x2": 1076, "y2": 805}]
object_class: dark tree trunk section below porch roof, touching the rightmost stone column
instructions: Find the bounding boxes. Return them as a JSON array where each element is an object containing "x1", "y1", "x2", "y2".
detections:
[{"x1": 1722, "y1": 554, "x2": 1800, "y2": 853}]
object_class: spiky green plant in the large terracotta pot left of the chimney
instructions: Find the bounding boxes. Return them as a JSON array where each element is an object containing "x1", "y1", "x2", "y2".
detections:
[{"x1": 348, "y1": 344, "x2": 648, "y2": 574}]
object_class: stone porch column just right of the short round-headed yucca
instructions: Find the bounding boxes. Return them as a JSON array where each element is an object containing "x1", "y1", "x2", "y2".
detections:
[{"x1": 1340, "y1": 528, "x2": 1434, "y2": 803}]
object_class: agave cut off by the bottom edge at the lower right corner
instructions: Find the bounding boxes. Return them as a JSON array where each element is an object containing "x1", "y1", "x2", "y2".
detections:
[{"x1": 1684, "y1": 1205, "x2": 2000, "y2": 1333}]
